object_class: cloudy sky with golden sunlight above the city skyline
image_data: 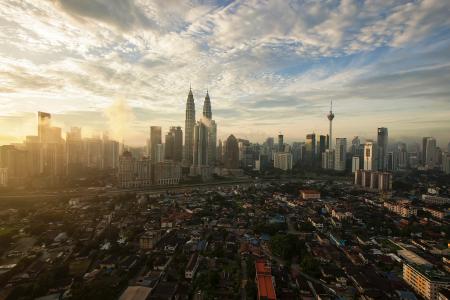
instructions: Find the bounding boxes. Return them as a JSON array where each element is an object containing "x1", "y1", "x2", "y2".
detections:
[{"x1": 0, "y1": 0, "x2": 450, "y2": 145}]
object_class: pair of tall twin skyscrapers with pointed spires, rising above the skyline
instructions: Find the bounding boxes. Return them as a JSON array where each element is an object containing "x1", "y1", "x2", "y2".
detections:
[{"x1": 184, "y1": 88, "x2": 217, "y2": 177}]
